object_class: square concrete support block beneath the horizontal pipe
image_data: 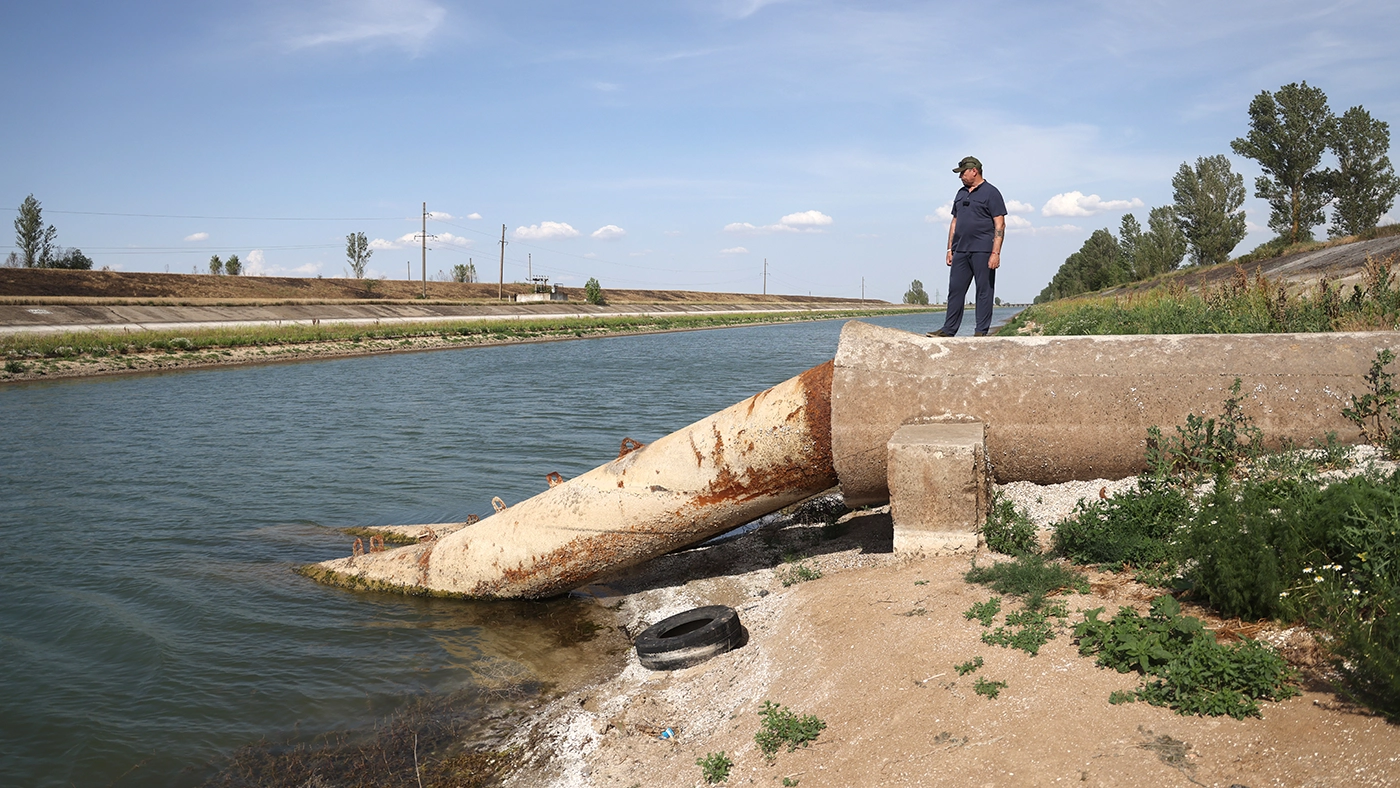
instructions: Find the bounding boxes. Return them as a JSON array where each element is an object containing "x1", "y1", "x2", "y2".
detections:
[{"x1": 886, "y1": 421, "x2": 991, "y2": 554}]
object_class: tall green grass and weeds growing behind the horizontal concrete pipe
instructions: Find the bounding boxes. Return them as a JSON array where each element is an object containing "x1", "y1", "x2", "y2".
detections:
[{"x1": 997, "y1": 255, "x2": 1400, "y2": 336}]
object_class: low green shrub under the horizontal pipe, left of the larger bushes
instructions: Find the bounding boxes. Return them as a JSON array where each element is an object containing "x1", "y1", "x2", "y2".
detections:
[{"x1": 1053, "y1": 483, "x2": 1191, "y2": 568}]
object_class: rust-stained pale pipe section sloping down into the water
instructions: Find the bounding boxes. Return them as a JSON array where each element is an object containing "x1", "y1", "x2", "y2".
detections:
[{"x1": 302, "y1": 361, "x2": 836, "y2": 598}]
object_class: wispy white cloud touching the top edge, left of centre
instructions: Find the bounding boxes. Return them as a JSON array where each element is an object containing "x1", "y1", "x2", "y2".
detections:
[{"x1": 276, "y1": 0, "x2": 447, "y2": 55}]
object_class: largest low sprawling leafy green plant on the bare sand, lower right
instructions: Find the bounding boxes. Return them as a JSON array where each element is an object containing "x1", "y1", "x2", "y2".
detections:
[{"x1": 1074, "y1": 596, "x2": 1298, "y2": 719}]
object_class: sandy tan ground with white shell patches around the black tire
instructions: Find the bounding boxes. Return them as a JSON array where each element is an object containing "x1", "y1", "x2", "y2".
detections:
[{"x1": 507, "y1": 480, "x2": 1400, "y2": 788}]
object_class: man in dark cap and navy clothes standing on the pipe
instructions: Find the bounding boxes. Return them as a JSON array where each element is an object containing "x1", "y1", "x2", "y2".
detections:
[{"x1": 928, "y1": 155, "x2": 1007, "y2": 336}]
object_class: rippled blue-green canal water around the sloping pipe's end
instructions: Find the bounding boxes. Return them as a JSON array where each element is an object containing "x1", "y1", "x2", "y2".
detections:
[{"x1": 0, "y1": 309, "x2": 1015, "y2": 787}]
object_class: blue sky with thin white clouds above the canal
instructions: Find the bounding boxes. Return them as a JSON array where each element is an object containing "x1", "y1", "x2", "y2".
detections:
[{"x1": 0, "y1": 0, "x2": 1400, "y2": 302}]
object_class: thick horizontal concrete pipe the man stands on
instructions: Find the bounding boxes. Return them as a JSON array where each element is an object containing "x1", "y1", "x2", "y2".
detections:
[{"x1": 832, "y1": 321, "x2": 1400, "y2": 507}]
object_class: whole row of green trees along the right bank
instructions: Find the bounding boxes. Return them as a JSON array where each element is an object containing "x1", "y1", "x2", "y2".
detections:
[{"x1": 1036, "y1": 81, "x2": 1400, "y2": 304}]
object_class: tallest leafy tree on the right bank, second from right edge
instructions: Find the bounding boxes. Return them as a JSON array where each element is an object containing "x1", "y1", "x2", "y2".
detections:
[{"x1": 1229, "y1": 81, "x2": 1337, "y2": 244}]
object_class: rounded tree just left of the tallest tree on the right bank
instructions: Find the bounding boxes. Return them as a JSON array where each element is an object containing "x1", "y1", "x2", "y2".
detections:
[{"x1": 1172, "y1": 155, "x2": 1245, "y2": 265}]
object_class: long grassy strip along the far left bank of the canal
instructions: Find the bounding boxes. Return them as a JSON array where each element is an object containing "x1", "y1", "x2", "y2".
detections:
[{"x1": 0, "y1": 309, "x2": 921, "y2": 381}]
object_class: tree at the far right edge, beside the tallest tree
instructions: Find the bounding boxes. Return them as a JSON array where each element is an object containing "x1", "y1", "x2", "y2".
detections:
[{"x1": 1327, "y1": 106, "x2": 1400, "y2": 238}]
